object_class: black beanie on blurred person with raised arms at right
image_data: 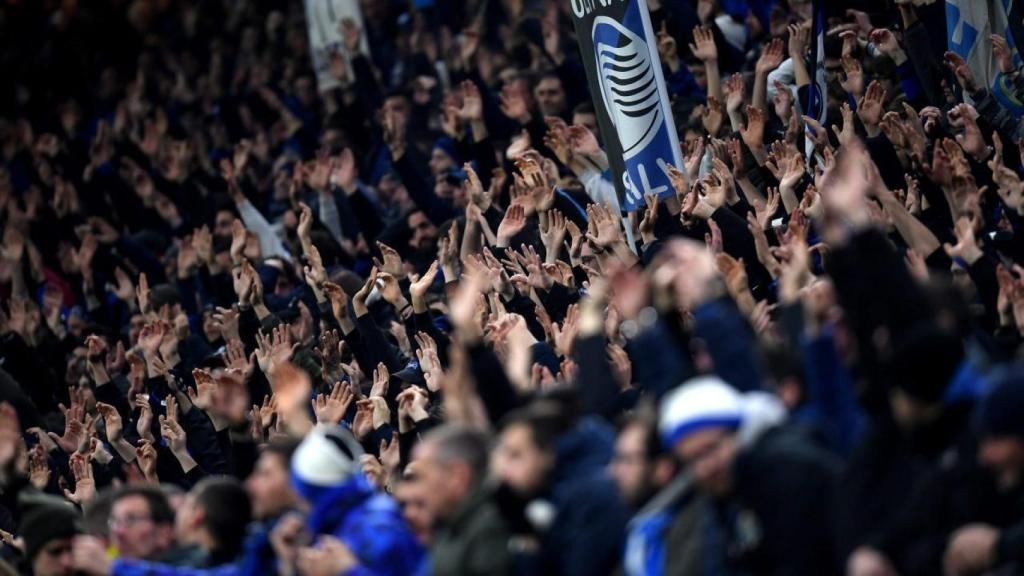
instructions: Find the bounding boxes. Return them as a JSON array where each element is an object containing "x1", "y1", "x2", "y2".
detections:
[{"x1": 889, "y1": 323, "x2": 964, "y2": 403}]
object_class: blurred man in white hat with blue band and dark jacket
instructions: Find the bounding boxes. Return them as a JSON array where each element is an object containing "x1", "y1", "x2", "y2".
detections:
[{"x1": 658, "y1": 376, "x2": 840, "y2": 574}]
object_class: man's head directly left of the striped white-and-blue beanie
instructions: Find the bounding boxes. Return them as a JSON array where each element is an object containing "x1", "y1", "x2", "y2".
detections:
[{"x1": 246, "y1": 440, "x2": 298, "y2": 520}]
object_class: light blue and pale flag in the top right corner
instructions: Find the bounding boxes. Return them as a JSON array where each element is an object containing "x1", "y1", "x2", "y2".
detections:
[{"x1": 946, "y1": 0, "x2": 1024, "y2": 117}]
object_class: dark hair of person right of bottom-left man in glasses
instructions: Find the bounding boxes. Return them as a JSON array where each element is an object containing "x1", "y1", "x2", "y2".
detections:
[{"x1": 193, "y1": 477, "x2": 252, "y2": 558}]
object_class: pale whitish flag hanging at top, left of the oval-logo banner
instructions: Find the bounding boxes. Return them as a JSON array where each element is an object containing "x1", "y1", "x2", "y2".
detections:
[{"x1": 305, "y1": 0, "x2": 369, "y2": 92}]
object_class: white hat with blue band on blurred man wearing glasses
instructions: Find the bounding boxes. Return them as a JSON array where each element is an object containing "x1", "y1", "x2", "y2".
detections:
[{"x1": 658, "y1": 376, "x2": 743, "y2": 449}]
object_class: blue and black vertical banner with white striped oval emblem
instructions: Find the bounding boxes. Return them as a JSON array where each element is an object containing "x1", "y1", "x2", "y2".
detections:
[{"x1": 571, "y1": 0, "x2": 683, "y2": 211}]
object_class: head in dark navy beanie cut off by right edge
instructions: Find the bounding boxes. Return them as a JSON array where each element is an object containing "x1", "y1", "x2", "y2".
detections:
[{"x1": 978, "y1": 367, "x2": 1024, "y2": 490}]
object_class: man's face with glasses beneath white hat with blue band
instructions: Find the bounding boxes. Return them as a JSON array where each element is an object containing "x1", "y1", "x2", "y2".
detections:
[{"x1": 676, "y1": 427, "x2": 736, "y2": 496}]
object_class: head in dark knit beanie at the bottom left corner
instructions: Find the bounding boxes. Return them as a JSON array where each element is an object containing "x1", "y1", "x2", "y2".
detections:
[{"x1": 18, "y1": 502, "x2": 81, "y2": 576}]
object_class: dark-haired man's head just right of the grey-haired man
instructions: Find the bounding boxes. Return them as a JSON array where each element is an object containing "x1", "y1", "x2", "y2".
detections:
[{"x1": 494, "y1": 402, "x2": 566, "y2": 497}]
